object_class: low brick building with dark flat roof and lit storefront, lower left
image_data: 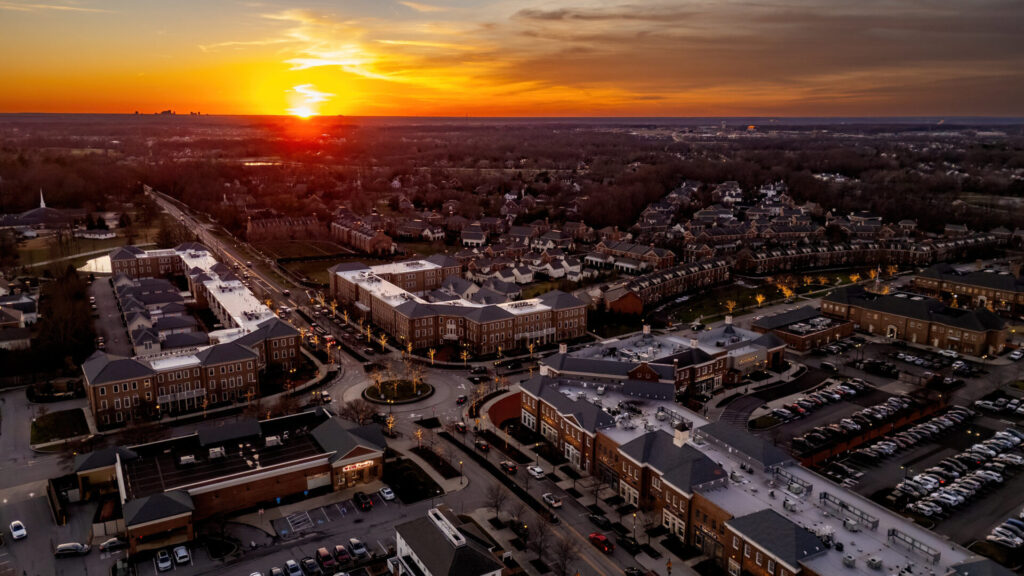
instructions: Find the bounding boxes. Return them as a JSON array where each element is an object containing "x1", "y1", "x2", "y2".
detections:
[{"x1": 65, "y1": 410, "x2": 386, "y2": 553}]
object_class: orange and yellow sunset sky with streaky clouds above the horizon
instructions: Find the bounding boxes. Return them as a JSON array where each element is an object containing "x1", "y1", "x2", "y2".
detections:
[{"x1": 0, "y1": 0, "x2": 1024, "y2": 116}]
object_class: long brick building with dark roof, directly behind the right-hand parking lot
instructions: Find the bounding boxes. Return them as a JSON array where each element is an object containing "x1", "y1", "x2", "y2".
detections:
[{"x1": 821, "y1": 286, "x2": 1009, "y2": 356}]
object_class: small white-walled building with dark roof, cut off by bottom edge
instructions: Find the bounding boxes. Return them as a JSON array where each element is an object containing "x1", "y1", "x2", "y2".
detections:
[{"x1": 388, "y1": 506, "x2": 504, "y2": 576}]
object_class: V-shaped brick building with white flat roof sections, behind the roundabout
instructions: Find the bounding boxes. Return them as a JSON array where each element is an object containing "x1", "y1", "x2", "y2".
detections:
[{"x1": 331, "y1": 255, "x2": 587, "y2": 355}]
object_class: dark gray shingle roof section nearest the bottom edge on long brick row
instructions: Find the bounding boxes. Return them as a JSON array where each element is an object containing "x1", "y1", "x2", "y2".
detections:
[{"x1": 725, "y1": 508, "x2": 825, "y2": 569}]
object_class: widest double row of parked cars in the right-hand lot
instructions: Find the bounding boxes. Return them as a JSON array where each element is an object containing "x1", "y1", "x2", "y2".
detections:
[{"x1": 896, "y1": 428, "x2": 1024, "y2": 517}]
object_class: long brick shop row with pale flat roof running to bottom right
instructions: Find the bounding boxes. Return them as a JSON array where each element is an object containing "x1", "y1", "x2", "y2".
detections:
[{"x1": 507, "y1": 376, "x2": 1005, "y2": 576}]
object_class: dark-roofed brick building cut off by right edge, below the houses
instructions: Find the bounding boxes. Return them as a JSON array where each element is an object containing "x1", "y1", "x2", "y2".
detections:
[{"x1": 911, "y1": 263, "x2": 1024, "y2": 316}]
